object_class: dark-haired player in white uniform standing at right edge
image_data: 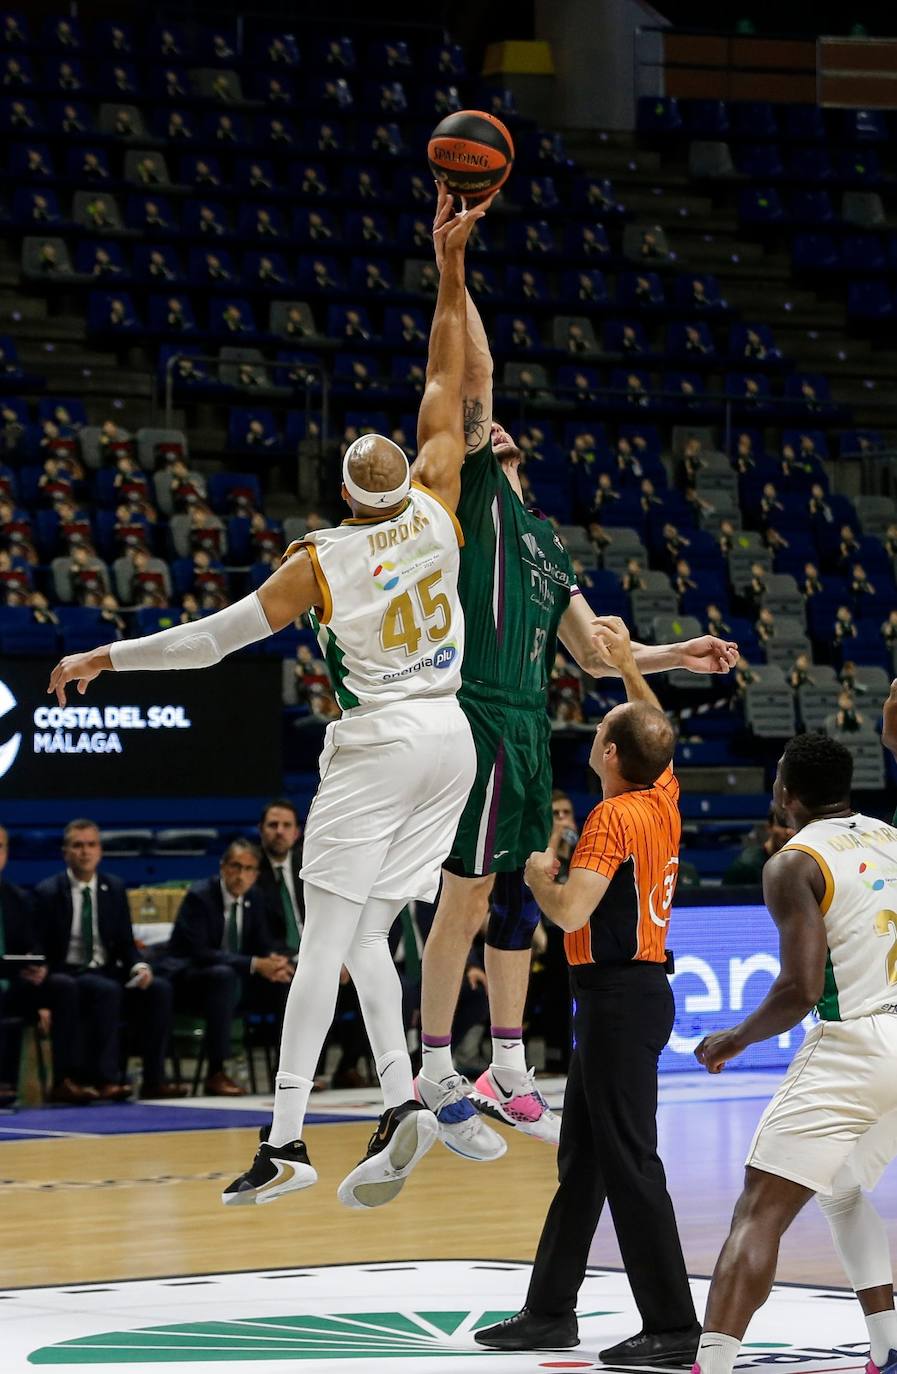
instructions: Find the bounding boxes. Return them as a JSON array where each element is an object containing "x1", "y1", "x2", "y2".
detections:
[{"x1": 695, "y1": 734, "x2": 897, "y2": 1374}]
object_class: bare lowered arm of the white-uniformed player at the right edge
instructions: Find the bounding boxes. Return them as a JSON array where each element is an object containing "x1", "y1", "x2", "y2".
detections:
[{"x1": 695, "y1": 849, "x2": 827, "y2": 1073}]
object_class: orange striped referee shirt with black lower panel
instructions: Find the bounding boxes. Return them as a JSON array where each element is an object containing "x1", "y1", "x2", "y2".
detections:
[{"x1": 563, "y1": 765, "x2": 683, "y2": 965}]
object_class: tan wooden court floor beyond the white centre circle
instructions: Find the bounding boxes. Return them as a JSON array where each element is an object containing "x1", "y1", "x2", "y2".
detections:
[{"x1": 0, "y1": 1099, "x2": 897, "y2": 1287}]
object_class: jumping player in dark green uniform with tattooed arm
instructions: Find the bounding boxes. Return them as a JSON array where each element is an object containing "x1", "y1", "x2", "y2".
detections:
[{"x1": 416, "y1": 187, "x2": 738, "y2": 1158}]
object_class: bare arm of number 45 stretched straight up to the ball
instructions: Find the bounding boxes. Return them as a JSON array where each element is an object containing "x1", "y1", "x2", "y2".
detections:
[{"x1": 412, "y1": 193, "x2": 486, "y2": 510}]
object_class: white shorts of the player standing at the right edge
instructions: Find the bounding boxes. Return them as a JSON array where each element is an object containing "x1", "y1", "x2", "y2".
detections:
[{"x1": 745, "y1": 1013, "x2": 897, "y2": 1194}]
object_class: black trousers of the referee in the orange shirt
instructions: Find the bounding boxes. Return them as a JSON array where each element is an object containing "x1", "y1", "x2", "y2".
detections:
[{"x1": 526, "y1": 963, "x2": 696, "y2": 1333}]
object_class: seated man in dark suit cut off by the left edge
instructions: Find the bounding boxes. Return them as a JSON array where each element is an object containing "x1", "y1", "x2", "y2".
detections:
[{"x1": 0, "y1": 826, "x2": 85, "y2": 1106}]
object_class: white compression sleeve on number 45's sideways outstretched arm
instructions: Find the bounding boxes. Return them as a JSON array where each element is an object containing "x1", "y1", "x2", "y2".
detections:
[{"x1": 110, "y1": 592, "x2": 273, "y2": 673}]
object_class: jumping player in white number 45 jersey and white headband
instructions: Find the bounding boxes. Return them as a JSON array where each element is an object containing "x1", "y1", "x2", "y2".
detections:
[{"x1": 49, "y1": 196, "x2": 504, "y2": 1206}]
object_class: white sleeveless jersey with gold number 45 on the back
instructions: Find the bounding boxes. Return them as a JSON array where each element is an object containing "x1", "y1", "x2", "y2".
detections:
[{"x1": 302, "y1": 482, "x2": 464, "y2": 712}]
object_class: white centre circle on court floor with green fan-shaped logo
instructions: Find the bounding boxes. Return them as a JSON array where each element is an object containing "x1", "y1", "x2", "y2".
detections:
[{"x1": 13, "y1": 1260, "x2": 868, "y2": 1374}]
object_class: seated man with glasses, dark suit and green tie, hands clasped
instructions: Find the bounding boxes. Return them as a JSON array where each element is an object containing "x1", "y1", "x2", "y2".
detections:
[{"x1": 161, "y1": 840, "x2": 293, "y2": 1098}]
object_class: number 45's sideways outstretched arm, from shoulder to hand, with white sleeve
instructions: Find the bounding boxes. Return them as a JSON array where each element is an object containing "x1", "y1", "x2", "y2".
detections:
[{"x1": 47, "y1": 548, "x2": 321, "y2": 706}]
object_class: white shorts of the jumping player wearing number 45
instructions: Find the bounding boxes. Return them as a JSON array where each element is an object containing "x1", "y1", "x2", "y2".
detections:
[{"x1": 301, "y1": 697, "x2": 477, "y2": 904}]
